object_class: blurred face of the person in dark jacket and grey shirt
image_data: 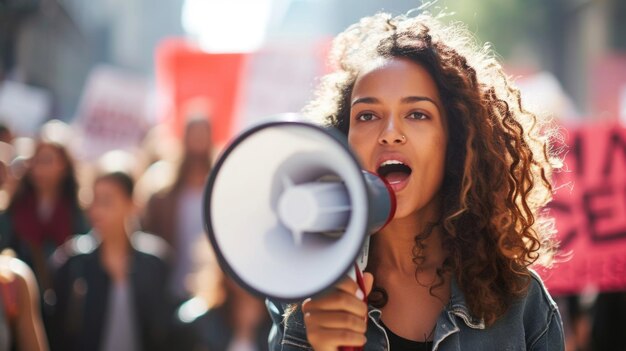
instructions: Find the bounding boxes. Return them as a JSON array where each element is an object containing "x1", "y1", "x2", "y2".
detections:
[{"x1": 89, "y1": 179, "x2": 133, "y2": 234}]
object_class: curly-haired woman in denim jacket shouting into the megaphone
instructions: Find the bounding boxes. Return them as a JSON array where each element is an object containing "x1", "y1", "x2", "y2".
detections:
[{"x1": 268, "y1": 14, "x2": 563, "y2": 351}]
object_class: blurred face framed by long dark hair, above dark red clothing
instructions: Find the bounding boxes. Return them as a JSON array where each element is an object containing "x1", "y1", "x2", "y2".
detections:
[{"x1": 31, "y1": 145, "x2": 67, "y2": 189}]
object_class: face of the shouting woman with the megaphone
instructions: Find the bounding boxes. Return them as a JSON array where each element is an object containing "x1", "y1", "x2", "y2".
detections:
[{"x1": 348, "y1": 58, "x2": 448, "y2": 218}]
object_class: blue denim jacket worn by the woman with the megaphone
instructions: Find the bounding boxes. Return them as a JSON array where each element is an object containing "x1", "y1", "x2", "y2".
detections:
[{"x1": 267, "y1": 271, "x2": 565, "y2": 351}]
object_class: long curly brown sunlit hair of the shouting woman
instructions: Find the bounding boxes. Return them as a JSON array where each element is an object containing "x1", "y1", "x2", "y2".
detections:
[{"x1": 304, "y1": 13, "x2": 559, "y2": 325}]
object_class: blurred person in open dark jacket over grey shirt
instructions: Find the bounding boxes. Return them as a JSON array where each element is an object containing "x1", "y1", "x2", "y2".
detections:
[{"x1": 50, "y1": 172, "x2": 171, "y2": 351}]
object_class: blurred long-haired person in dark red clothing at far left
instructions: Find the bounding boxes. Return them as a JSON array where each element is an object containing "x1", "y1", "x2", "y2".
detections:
[{"x1": 3, "y1": 141, "x2": 88, "y2": 292}]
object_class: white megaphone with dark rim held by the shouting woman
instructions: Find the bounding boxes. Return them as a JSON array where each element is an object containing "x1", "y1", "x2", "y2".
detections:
[{"x1": 204, "y1": 115, "x2": 395, "y2": 302}]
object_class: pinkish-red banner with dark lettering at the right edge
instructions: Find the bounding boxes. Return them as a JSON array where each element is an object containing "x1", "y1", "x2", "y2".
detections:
[{"x1": 543, "y1": 124, "x2": 626, "y2": 295}]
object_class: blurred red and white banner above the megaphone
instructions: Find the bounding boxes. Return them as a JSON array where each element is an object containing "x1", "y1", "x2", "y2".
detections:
[{"x1": 156, "y1": 38, "x2": 330, "y2": 147}]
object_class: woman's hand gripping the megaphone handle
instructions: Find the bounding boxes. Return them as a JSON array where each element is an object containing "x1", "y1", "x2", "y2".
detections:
[{"x1": 302, "y1": 273, "x2": 374, "y2": 351}]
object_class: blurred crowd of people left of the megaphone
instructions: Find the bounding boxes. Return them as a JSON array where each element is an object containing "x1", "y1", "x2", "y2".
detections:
[{"x1": 0, "y1": 118, "x2": 271, "y2": 351}]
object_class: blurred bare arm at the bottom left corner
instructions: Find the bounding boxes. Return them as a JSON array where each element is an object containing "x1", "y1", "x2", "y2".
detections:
[{"x1": 11, "y1": 259, "x2": 48, "y2": 351}]
